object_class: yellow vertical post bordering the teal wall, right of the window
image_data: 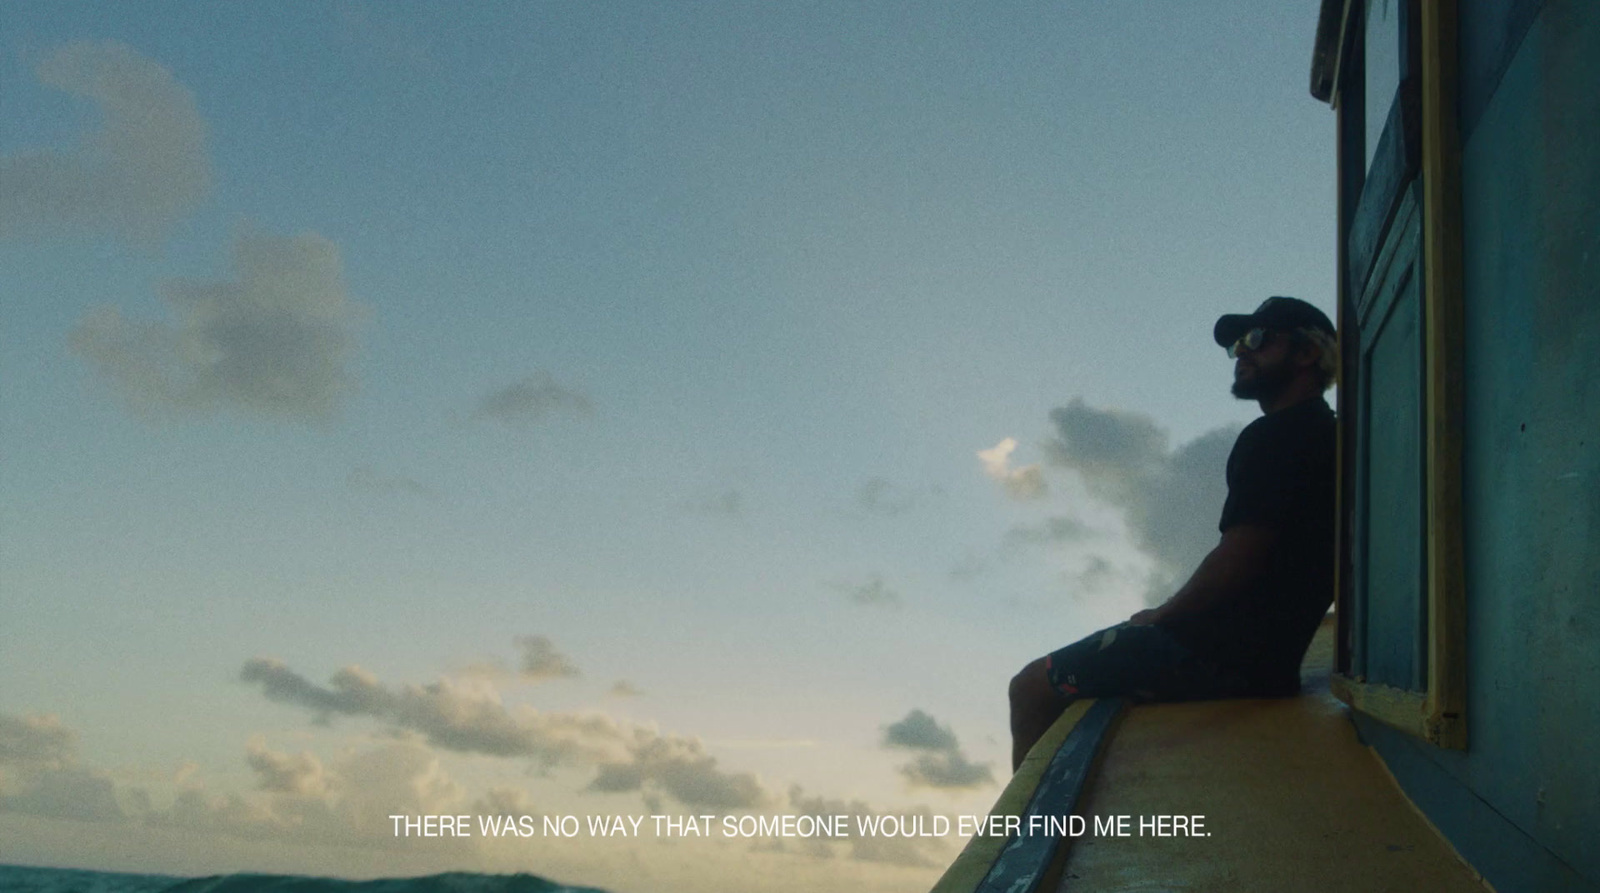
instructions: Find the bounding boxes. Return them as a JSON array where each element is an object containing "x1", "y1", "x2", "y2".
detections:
[{"x1": 1422, "y1": 0, "x2": 1467, "y2": 749}]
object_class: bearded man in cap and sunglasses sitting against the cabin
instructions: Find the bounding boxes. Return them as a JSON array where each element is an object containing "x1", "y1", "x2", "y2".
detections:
[{"x1": 1011, "y1": 298, "x2": 1338, "y2": 770}]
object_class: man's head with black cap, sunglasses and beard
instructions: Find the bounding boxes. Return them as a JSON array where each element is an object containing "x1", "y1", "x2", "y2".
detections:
[{"x1": 1211, "y1": 298, "x2": 1338, "y2": 408}]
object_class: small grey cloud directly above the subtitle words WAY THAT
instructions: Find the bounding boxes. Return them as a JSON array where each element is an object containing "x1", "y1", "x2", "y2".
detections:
[{"x1": 589, "y1": 730, "x2": 774, "y2": 811}]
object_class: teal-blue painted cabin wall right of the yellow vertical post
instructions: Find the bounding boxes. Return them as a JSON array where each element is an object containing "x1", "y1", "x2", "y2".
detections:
[{"x1": 1347, "y1": 0, "x2": 1600, "y2": 893}]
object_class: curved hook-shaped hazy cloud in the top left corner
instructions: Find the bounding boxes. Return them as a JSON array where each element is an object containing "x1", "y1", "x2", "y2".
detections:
[{"x1": 0, "y1": 40, "x2": 211, "y2": 248}]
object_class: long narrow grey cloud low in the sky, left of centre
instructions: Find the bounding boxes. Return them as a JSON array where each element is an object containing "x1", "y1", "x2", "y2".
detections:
[{"x1": 240, "y1": 658, "x2": 622, "y2": 763}]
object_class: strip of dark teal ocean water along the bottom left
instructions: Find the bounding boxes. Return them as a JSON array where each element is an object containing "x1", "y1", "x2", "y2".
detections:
[{"x1": 0, "y1": 866, "x2": 605, "y2": 893}]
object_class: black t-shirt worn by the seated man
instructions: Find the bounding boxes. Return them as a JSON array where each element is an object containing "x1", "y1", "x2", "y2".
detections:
[{"x1": 1162, "y1": 397, "x2": 1336, "y2": 695}]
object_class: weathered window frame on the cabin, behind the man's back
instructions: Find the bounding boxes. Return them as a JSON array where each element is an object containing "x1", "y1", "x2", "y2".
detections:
[{"x1": 1312, "y1": 0, "x2": 1467, "y2": 749}]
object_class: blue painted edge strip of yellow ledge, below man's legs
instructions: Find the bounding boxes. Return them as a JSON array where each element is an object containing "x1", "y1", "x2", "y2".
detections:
[{"x1": 973, "y1": 698, "x2": 1123, "y2": 893}]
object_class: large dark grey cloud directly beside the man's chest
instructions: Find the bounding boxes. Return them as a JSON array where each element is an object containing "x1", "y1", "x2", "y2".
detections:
[{"x1": 1046, "y1": 400, "x2": 1238, "y2": 603}]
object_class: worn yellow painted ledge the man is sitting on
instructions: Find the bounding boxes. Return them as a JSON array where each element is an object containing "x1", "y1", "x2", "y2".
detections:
[{"x1": 1056, "y1": 697, "x2": 1491, "y2": 893}]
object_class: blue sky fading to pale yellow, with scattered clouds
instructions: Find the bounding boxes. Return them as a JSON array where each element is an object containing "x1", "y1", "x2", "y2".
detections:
[{"x1": 0, "y1": 0, "x2": 1334, "y2": 893}]
